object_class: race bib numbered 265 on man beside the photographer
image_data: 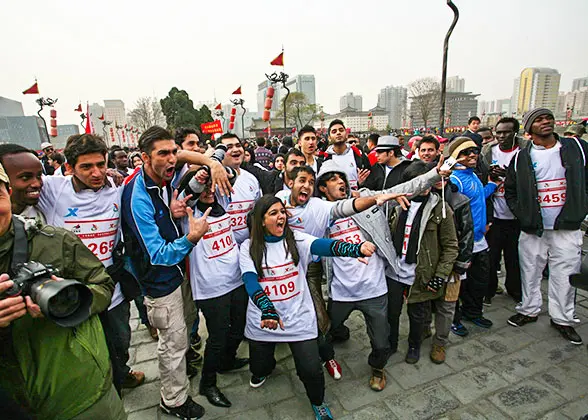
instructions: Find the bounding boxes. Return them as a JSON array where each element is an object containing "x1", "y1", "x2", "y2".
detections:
[{"x1": 65, "y1": 217, "x2": 120, "y2": 266}]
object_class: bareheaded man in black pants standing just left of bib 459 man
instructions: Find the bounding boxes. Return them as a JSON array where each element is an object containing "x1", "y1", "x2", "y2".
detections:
[{"x1": 482, "y1": 118, "x2": 528, "y2": 305}]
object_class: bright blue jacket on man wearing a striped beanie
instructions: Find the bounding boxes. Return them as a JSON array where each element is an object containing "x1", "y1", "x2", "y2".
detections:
[{"x1": 449, "y1": 168, "x2": 497, "y2": 242}]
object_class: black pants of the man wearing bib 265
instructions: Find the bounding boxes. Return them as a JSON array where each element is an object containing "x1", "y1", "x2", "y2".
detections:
[{"x1": 100, "y1": 300, "x2": 131, "y2": 396}]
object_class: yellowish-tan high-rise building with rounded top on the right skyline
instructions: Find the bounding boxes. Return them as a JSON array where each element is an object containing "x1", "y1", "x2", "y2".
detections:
[{"x1": 517, "y1": 67, "x2": 561, "y2": 115}]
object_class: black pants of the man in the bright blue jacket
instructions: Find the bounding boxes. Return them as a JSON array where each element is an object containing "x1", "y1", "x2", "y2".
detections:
[{"x1": 453, "y1": 249, "x2": 496, "y2": 324}]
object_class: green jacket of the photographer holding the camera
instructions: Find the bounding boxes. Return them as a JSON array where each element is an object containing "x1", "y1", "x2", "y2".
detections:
[{"x1": 0, "y1": 221, "x2": 114, "y2": 419}]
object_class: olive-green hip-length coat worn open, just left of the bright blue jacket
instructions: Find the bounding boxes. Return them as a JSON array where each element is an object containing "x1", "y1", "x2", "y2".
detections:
[{"x1": 390, "y1": 193, "x2": 459, "y2": 303}]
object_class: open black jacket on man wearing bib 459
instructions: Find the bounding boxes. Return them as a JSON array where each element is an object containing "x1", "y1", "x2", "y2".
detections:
[{"x1": 504, "y1": 134, "x2": 588, "y2": 236}]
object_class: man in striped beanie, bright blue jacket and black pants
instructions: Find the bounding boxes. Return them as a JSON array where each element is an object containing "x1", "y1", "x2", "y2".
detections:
[{"x1": 445, "y1": 137, "x2": 497, "y2": 337}]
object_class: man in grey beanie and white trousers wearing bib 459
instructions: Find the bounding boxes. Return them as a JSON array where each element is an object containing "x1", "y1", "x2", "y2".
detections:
[{"x1": 505, "y1": 108, "x2": 588, "y2": 345}]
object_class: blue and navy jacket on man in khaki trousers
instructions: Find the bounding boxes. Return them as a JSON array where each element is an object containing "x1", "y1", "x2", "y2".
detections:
[{"x1": 122, "y1": 169, "x2": 194, "y2": 298}]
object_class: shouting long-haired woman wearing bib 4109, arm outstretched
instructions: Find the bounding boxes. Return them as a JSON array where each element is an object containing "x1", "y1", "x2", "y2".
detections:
[{"x1": 239, "y1": 195, "x2": 375, "y2": 420}]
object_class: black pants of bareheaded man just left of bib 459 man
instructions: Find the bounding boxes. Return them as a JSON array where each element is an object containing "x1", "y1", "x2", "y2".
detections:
[{"x1": 486, "y1": 219, "x2": 522, "y2": 302}]
